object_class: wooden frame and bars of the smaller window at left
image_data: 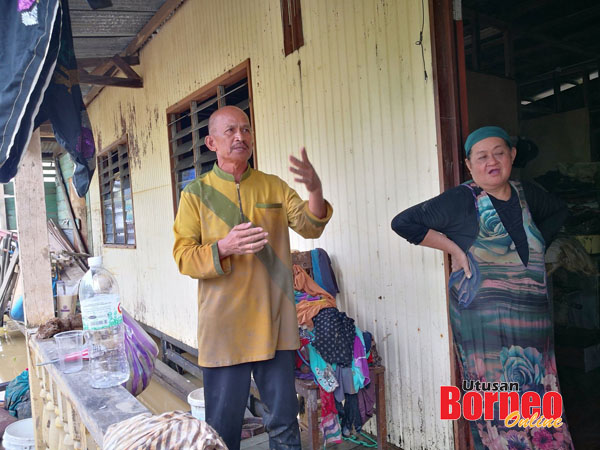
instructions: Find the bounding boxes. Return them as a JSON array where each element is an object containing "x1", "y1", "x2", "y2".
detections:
[{"x1": 96, "y1": 133, "x2": 137, "y2": 249}]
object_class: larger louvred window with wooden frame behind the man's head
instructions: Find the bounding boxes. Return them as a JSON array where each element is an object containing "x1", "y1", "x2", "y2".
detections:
[{"x1": 167, "y1": 61, "x2": 255, "y2": 211}]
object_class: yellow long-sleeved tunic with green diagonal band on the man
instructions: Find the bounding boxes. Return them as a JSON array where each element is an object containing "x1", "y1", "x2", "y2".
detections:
[{"x1": 173, "y1": 164, "x2": 333, "y2": 367}]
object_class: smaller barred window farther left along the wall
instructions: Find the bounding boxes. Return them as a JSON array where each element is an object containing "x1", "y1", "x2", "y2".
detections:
[{"x1": 98, "y1": 137, "x2": 135, "y2": 247}]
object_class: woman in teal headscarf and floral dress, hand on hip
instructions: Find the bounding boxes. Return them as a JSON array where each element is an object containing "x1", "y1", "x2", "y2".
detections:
[{"x1": 392, "y1": 127, "x2": 573, "y2": 449}]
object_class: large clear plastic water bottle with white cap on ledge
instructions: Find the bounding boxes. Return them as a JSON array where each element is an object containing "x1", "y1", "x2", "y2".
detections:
[{"x1": 79, "y1": 256, "x2": 129, "y2": 388}]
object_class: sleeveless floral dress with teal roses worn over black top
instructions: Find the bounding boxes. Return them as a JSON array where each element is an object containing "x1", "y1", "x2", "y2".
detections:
[{"x1": 450, "y1": 182, "x2": 573, "y2": 450}]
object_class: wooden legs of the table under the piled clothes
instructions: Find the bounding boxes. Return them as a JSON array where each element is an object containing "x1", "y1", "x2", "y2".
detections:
[{"x1": 296, "y1": 366, "x2": 387, "y2": 450}]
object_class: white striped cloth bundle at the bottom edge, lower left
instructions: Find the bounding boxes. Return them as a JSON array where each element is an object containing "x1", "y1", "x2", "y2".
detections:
[{"x1": 102, "y1": 411, "x2": 227, "y2": 450}]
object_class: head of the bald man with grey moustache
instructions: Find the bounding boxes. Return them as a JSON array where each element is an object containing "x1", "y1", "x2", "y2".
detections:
[{"x1": 206, "y1": 107, "x2": 253, "y2": 166}]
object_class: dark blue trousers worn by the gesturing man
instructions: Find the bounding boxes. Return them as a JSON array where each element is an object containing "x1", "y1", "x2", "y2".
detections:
[{"x1": 202, "y1": 350, "x2": 301, "y2": 450}]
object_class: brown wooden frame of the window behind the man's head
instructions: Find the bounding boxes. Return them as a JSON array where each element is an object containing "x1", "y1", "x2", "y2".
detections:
[{"x1": 166, "y1": 58, "x2": 258, "y2": 217}]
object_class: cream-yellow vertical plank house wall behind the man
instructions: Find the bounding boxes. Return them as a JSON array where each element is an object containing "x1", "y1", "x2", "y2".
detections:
[{"x1": 84, "y1": 0, "x2": 453, "y2": 449}]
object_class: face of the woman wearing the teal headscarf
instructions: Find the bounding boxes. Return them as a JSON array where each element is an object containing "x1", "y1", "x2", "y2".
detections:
[{"x1": 466, "y1": 137, "x2": 517, "y2": 191}]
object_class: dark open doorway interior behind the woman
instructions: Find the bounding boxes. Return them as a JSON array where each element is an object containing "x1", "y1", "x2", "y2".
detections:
[{"x1": 454, "y1": 0, "x2": 600, "y2": 450}]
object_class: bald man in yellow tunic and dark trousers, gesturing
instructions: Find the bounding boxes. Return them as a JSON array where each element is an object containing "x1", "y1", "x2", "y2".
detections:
[{"x1": 173, "y1": 106, "x2": 333, "y2": 450}]
